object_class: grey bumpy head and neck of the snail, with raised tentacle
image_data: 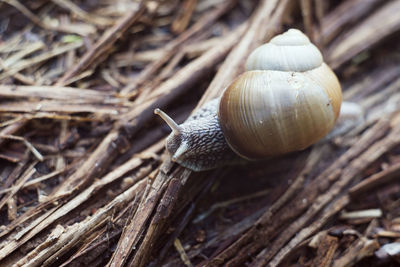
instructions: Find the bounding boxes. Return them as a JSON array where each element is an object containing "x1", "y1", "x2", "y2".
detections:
[{"x1": 154, "y1": 99, "x2": 240, "y2": 171}]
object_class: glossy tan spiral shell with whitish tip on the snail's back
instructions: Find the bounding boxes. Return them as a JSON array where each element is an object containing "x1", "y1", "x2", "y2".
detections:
[{"x1": 218, "y1": 29, "x2": 342, "y2": 159}]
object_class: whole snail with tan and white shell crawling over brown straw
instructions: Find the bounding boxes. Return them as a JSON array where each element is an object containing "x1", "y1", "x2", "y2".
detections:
[{"x1": 154, "y1": 29, "x2": 342, "y2": 171}]
